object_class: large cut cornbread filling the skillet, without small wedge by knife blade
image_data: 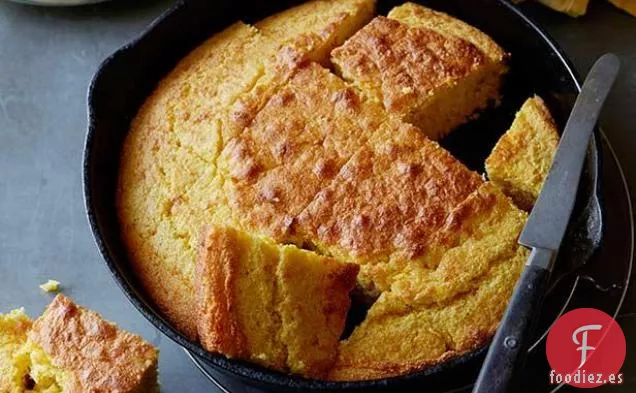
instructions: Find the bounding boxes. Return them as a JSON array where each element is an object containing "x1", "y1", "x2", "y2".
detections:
[{"x1": 117, "y1": 0, "x2": 525, "y2": 379}]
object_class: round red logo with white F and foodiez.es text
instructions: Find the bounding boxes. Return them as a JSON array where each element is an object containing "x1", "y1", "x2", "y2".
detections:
[{"x1": 546, "y1": 308, "x2": 626, "y2": 388}]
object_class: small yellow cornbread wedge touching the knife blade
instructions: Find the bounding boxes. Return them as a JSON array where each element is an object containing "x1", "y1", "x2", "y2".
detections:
[{"x1": 486, "y1": 96, "x2": 559, "y2": 210}]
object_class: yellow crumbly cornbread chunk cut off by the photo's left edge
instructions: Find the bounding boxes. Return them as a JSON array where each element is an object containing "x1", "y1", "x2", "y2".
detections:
[{"x1": 0, "y1": 309, "x2": 32, "y2": 393}]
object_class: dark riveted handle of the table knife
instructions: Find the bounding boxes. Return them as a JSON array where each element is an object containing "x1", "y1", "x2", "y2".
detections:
[{"x1": 473, "y1": 248, "x2": 554, "y2": 393}]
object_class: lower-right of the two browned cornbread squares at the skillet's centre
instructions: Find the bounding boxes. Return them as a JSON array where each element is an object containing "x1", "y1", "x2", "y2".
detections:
[{"x1": 296, "y1": 115, "x2": 482, "y2": 295}]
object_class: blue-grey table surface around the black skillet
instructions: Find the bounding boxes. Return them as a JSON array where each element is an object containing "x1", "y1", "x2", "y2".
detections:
[{"x1": 0, "y1": 0, "x2": 636, "y2": 393}]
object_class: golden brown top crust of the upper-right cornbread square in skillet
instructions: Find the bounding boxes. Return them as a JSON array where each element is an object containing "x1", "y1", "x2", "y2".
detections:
[{"x1": 332, "y1": 16, "x2": 485, "y2": 112}]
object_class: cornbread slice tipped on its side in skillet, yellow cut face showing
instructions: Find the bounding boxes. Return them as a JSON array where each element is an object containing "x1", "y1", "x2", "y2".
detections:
[{"x1": 197, "y1": 227, "x2": 358, "y2": 377}]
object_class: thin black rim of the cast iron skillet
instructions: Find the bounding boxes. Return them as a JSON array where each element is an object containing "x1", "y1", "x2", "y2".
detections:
[{"x1": 83, "y1": 0, "x2": 603, "y2": 391}]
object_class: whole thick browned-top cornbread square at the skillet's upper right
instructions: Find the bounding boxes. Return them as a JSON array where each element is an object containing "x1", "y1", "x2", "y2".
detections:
[{"x1": 331, "y1": 3, "x2": 506, "y2": 139}]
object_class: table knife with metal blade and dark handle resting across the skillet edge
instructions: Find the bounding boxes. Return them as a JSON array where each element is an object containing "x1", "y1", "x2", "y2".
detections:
[{"x1": 473, "y1": 53, "x2": 620, "y2": 393}]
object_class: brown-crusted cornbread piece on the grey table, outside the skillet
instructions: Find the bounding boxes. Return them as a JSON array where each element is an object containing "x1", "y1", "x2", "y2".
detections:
[{"x1": 28, "y1": 295, "x2": 158, "y2": 393}]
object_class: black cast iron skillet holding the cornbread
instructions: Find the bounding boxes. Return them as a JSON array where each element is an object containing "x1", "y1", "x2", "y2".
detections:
[{"x1": 84, "y1": 0, "x2": 602, "y2": 392}]
